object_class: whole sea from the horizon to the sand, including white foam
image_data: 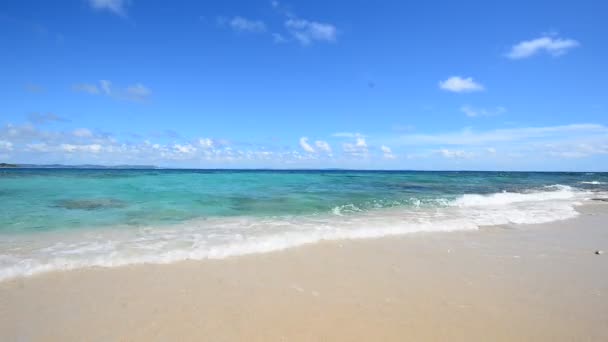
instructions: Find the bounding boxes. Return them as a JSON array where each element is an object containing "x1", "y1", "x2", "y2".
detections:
[{"x1": 0, "y1": 169, "x2": 608, "y2": 280}]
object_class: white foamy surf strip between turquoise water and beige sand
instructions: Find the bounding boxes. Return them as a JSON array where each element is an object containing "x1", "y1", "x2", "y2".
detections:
[{"x1": 0, "y1": 185, "x2": 590, "y2": 280}]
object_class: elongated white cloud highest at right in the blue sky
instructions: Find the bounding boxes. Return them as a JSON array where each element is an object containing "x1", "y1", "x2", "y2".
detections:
[{"x1": 507, "y1": 37, "x2": 580, "y2": 59}]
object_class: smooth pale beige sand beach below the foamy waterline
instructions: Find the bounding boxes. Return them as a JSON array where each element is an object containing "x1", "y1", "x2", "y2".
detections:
[{"x1": 0, "y1": 203, "x2": 608, "y2": 341}]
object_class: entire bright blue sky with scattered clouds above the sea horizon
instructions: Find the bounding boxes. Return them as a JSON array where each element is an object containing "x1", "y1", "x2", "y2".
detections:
[{"x1": 0, "y1": 0, "x2": 608, "y2": 171}]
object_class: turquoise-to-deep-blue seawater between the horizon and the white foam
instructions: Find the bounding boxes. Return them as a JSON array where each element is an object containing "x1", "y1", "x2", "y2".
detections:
[{"x1": 0, "y1": 169, "x2": 608, "y2": 233}]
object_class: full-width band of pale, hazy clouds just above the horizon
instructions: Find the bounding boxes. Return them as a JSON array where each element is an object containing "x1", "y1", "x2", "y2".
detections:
[{"x1": 0, "y1": 118, "x2": 608, "y2": 169}]
